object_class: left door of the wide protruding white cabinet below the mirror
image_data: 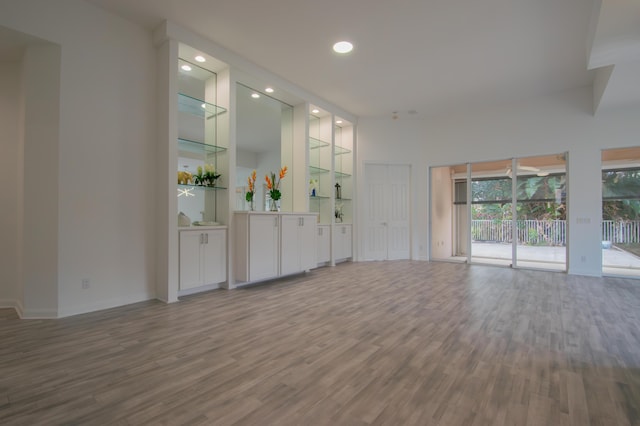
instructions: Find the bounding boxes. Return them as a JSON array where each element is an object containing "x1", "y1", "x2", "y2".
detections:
[{"x1": 249, "y1": 214, "x2": 279, "y2": 281}]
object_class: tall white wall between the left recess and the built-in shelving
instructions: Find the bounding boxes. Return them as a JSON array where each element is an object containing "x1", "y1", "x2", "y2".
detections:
[{"x1": 0, "y1": 0, "x2": 157, "y2": 316}]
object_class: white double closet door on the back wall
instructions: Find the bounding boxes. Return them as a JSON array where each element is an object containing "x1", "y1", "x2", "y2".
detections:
[{"x1": 363, "y1": 164, "x2": 411, "y2": 260}]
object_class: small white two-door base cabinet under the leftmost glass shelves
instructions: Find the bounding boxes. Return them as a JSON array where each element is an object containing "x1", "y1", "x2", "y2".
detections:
[{"x1": 180, "y1": 229, "x2": 227, "y2": 290}]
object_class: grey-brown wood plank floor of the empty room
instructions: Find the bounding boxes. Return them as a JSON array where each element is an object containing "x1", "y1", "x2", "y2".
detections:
[{"x1": 0, "y1": 261, "x2": 640, "y2": 426}]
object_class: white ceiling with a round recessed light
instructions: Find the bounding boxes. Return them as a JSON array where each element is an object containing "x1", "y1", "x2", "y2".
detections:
[{"x1": 0, "y1": 0, "x2": 640, "y2": 117}]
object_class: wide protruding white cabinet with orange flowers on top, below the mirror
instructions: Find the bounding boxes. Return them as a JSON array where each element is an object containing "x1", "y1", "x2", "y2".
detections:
[{"x1": 234, "y1": 211, "x2": 318, "y2": 283}]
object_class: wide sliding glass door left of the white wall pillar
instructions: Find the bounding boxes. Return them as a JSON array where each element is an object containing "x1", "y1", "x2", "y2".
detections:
[{"x1": 430, "y1": 154, "x2": 567, "y2": 270}]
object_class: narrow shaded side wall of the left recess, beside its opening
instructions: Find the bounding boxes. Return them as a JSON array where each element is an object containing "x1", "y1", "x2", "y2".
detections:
[{"x1": 21, "y1": 43, "x2": 61, "y2": 318}]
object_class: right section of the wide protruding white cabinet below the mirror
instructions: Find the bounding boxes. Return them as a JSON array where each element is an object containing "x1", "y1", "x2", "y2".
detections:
[{"x1": 280, "y1": 214, "x2": 317, "y2": 275}]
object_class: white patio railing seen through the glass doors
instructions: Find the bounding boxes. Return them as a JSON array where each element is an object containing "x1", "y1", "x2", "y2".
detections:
[{"x1": 471, "y1": 220, "x2": 640, "y2": 246}]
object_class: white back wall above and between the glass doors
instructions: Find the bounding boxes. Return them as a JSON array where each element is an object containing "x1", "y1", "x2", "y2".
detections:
[{"x1": 358, "y1": 87, "x2": 640, "y2": 275}]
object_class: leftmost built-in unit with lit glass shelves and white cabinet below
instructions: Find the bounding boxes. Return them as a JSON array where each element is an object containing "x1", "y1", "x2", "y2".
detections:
[{"x1": 174, "y1": 50, "x2": 230, "y2": 295}]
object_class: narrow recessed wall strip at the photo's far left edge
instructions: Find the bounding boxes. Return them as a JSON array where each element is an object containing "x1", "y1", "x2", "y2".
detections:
[{"x1": 0, "y1": 62, "x2": 22, "y2": 309}]
